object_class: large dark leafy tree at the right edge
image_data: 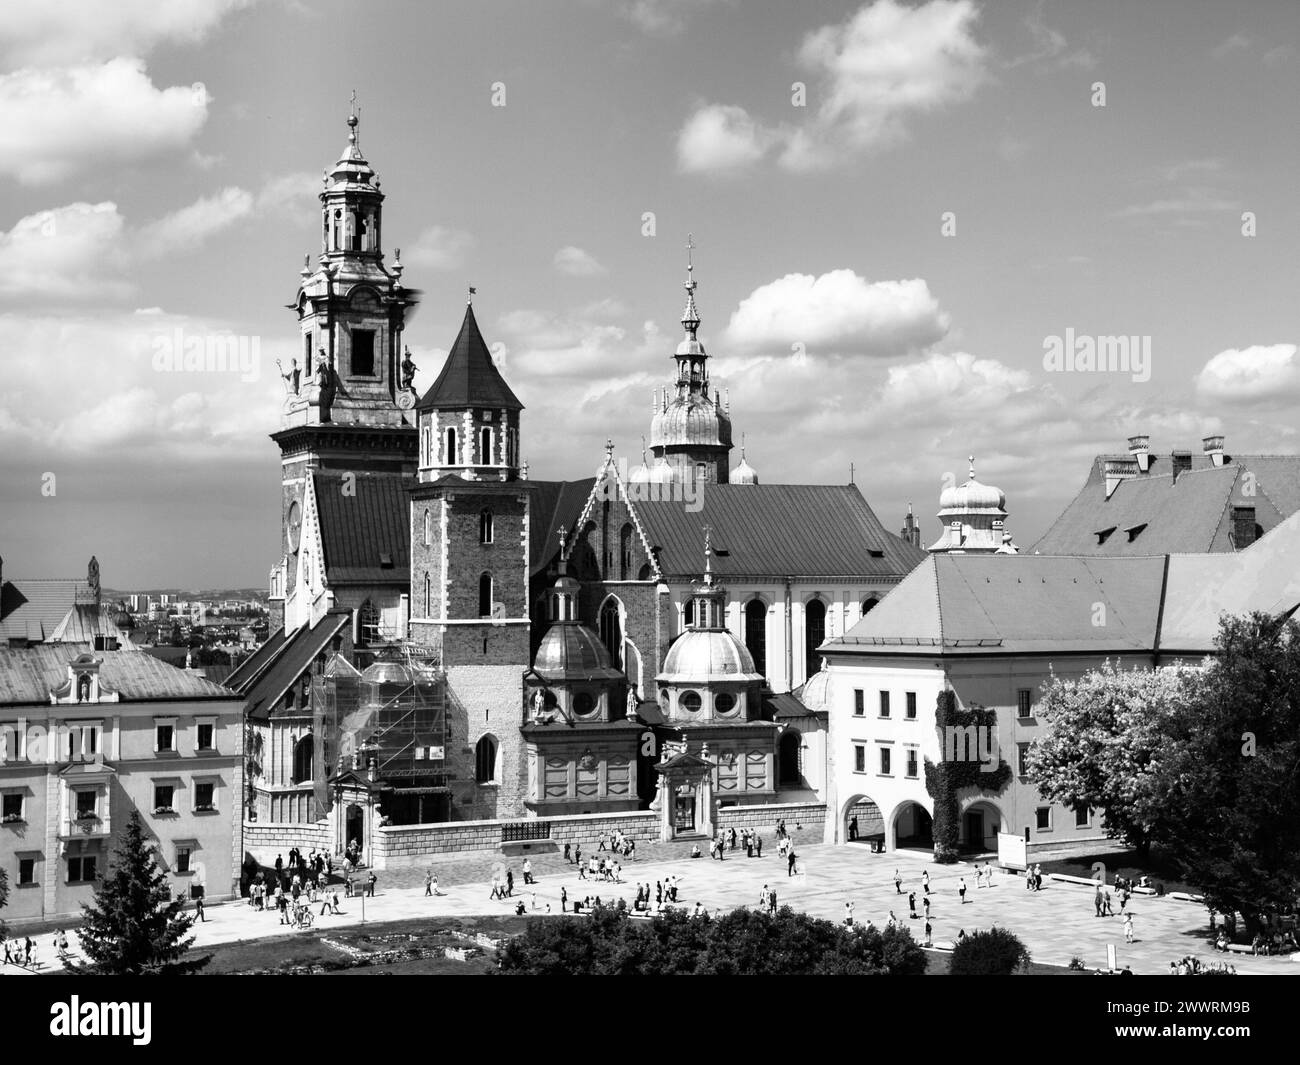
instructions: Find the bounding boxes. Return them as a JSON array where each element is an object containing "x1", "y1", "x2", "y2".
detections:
[{"x1": 1158, "y1": 612, "x2": 1300, "y2": 932}]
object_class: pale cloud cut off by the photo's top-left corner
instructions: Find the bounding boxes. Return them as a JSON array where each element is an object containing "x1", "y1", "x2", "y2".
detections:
[{"x1": 0, "y1": 0, "x2": 255, "y2": 65}]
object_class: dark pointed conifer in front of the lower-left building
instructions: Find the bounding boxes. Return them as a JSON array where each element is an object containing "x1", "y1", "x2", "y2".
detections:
[{"x1": 70, "y1": 810, "x2": 208, "y2": 975}]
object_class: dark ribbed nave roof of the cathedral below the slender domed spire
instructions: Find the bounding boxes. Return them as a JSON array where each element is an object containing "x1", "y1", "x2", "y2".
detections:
[{"x1": 632, "y1": 484, "x2": 927, "y2": 580}]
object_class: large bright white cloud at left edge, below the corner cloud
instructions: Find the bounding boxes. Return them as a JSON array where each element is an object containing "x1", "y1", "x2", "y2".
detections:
[{"x1": 0, "y1": 59, "x2": 211, "y2": 185}]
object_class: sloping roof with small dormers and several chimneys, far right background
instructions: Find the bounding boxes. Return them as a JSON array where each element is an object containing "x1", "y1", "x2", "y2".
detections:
[{"x1": 1030, "y1": 454, "x2": 1300, "y2": 557}]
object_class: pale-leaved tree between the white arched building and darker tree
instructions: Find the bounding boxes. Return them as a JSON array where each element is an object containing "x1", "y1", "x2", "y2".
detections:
[{"x1": 1027, "y1": 662, "x2": 1200, "y2": 858}]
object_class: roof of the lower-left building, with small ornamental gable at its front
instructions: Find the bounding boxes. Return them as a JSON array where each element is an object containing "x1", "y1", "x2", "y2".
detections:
[{"x1": 0, "y1": 644, "x2": 234, "y2": 705}]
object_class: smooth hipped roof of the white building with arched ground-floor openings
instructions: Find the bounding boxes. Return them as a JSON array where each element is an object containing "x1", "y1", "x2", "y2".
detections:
[{"x1": 824, "y1": 554, "x2": 1165, "y2": 654}]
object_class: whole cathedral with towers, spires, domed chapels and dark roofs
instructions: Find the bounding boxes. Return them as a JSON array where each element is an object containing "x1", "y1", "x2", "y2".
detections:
[{"x1": 228, "y1": 108, "x2": 926, "y2": 848}]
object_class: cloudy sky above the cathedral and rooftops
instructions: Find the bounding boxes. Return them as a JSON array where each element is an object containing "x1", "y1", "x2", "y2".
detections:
[{"x1": 0, "y1": 0, "x2": 1300, "y2": 589}]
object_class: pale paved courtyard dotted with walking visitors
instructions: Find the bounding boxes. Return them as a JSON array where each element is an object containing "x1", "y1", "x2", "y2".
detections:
[{"x1": 12, "y1": 832, "x2": 1300, "y2": 975}]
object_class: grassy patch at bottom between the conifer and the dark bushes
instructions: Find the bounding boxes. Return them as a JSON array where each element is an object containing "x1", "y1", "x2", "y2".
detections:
[{"x1": 195, "y1": 917, "x2": 523, "y2": 975}]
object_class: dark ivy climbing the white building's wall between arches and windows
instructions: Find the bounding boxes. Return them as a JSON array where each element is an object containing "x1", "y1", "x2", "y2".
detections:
[{"x1": 926, "y1": 692, "x2": 1011, "y2": 863}]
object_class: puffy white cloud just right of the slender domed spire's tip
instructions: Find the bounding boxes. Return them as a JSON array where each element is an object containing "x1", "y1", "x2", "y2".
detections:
[{"x1": 725, "y1": 269, "x2": 948, "y2": 355}]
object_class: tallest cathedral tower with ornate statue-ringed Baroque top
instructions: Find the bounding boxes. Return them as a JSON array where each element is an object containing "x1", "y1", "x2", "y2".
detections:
[{"x1": 270, "y1": 105, "x2": 420, "y2": 636}]
